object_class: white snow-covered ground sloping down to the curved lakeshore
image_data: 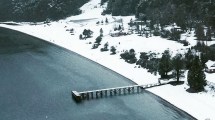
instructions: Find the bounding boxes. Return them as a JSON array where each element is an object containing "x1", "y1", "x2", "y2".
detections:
[{"x1": 0, "y1": 0, "x2": 215, "y2": 120}]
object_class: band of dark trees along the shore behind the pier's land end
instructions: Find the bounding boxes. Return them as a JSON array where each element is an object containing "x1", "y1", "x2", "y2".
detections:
[{"x1": 120, "y1": 48, "x2": 207, "y2": 92}]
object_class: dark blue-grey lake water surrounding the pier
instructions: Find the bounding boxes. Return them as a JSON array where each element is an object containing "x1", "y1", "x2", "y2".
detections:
[{"x1": 0, "y1": 28, "x2": 194, "y2": 120}]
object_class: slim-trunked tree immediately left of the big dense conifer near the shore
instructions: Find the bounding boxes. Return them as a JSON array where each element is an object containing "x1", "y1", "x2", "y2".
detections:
[{"x1": 172, "y1": 53, "x2": 184, "y2": 82}]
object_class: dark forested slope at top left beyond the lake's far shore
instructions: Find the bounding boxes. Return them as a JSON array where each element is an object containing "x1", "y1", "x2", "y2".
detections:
[{"x1": 0, "y1": 0, "x2": 89, "y2": 22}]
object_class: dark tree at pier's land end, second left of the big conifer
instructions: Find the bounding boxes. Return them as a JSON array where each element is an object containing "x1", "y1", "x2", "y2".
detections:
[{"x1": 158, "y1": 50, "x2": 172, "y2": 78}]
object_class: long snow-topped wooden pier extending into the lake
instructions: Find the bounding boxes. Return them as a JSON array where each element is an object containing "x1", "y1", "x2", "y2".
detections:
[{"x1": 72, "y1": 83, "x2": 168, "y2": 102}]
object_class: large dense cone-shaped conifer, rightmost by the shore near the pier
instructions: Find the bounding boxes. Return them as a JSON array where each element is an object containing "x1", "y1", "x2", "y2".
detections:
[{"x1": 187, "y1": 56, "x2": 206, "y2": 92}]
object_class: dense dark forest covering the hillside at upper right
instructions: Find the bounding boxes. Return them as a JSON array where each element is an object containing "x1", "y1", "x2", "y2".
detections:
[{"x1": 103, "y1": 0, "x2": 215, "y2": 30}]
